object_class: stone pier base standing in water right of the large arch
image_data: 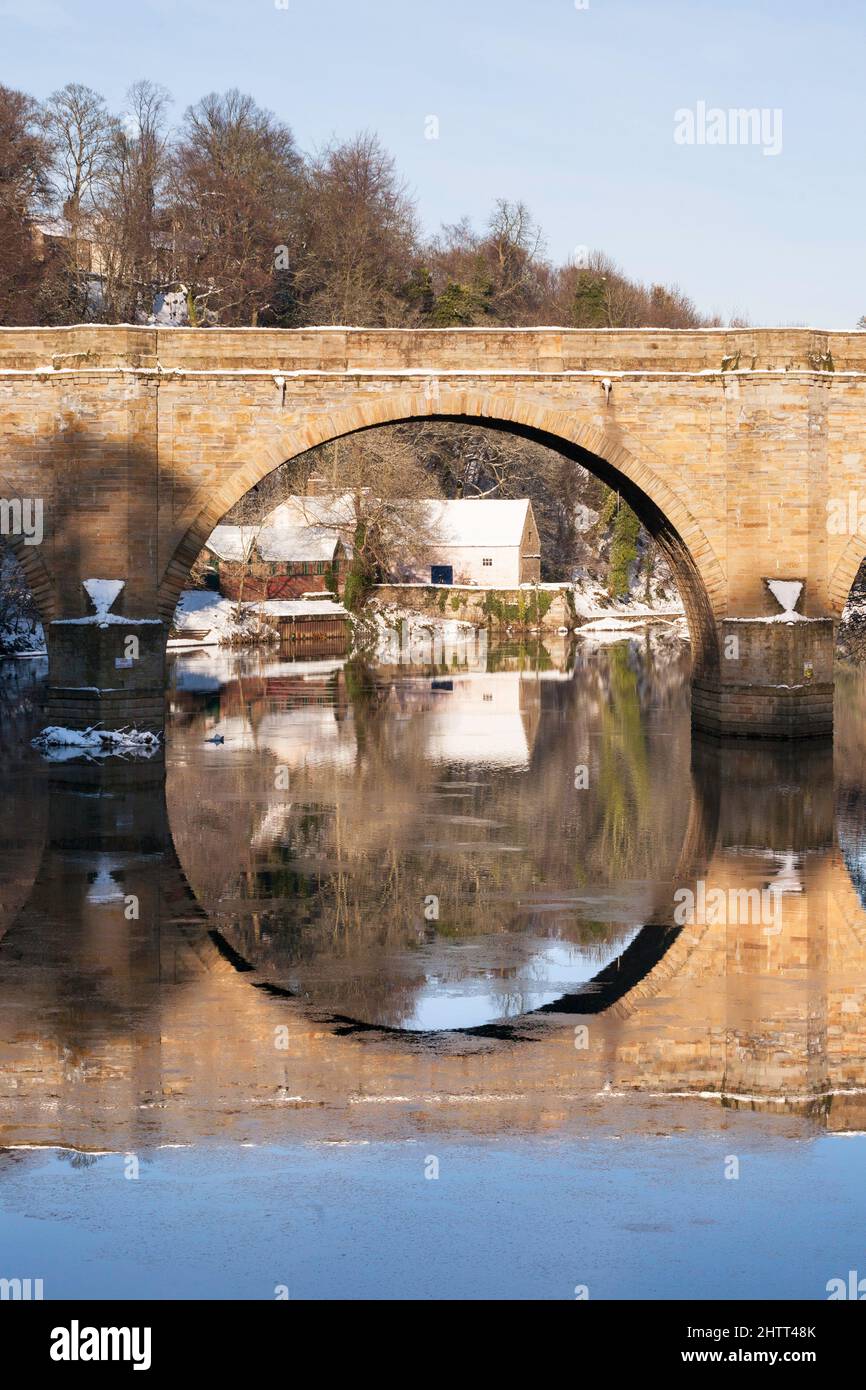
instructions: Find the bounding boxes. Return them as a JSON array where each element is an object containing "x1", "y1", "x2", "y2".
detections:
[{"x1": 692, "y1": 614, "x2": 835, "y2": 739}]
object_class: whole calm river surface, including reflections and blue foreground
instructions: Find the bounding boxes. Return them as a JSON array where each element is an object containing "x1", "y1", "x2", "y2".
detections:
[{"x1": 0, "y1": 635, "x2": 866, "y2": 1297}]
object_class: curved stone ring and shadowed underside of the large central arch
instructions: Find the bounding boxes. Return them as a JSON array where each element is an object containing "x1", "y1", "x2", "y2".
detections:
[{"x1": 158, "y1": 382, "x2": 726, "y2": 677}]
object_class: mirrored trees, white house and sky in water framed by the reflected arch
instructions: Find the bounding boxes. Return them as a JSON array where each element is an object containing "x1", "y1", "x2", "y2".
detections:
[{"x1": 168, "y1": 644, "x2": 688, "y2": 1030}]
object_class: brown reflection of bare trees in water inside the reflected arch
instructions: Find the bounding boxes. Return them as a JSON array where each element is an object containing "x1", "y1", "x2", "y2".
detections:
[{"x1": 170, "y1": 646, "x2": 689, "y2": 1024}]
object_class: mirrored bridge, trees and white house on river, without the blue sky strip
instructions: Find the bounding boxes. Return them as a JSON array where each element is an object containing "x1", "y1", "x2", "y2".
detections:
[{"x1": 0, "y1": 641, "x2": 866, "y2": 1148}]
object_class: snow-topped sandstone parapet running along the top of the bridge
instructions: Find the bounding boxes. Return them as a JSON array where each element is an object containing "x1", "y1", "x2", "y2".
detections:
[{"x1": 0, "y1": 324, "x2": 866, "y2": 377}]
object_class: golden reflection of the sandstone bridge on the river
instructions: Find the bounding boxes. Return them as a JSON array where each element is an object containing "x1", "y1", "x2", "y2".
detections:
[{"x1": 0, "y1": 745, "x2": 866, "y2": 1148}]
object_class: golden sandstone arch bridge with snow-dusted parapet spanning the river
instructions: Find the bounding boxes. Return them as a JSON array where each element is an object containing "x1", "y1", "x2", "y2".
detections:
[{"x1": 0, "y1": 327, "x2": 866, "y2": 737}]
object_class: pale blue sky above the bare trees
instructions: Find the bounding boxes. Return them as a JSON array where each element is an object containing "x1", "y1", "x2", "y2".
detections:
[{"x1": 0, "y1": 0, "x2": 866, "y2": 328}]
